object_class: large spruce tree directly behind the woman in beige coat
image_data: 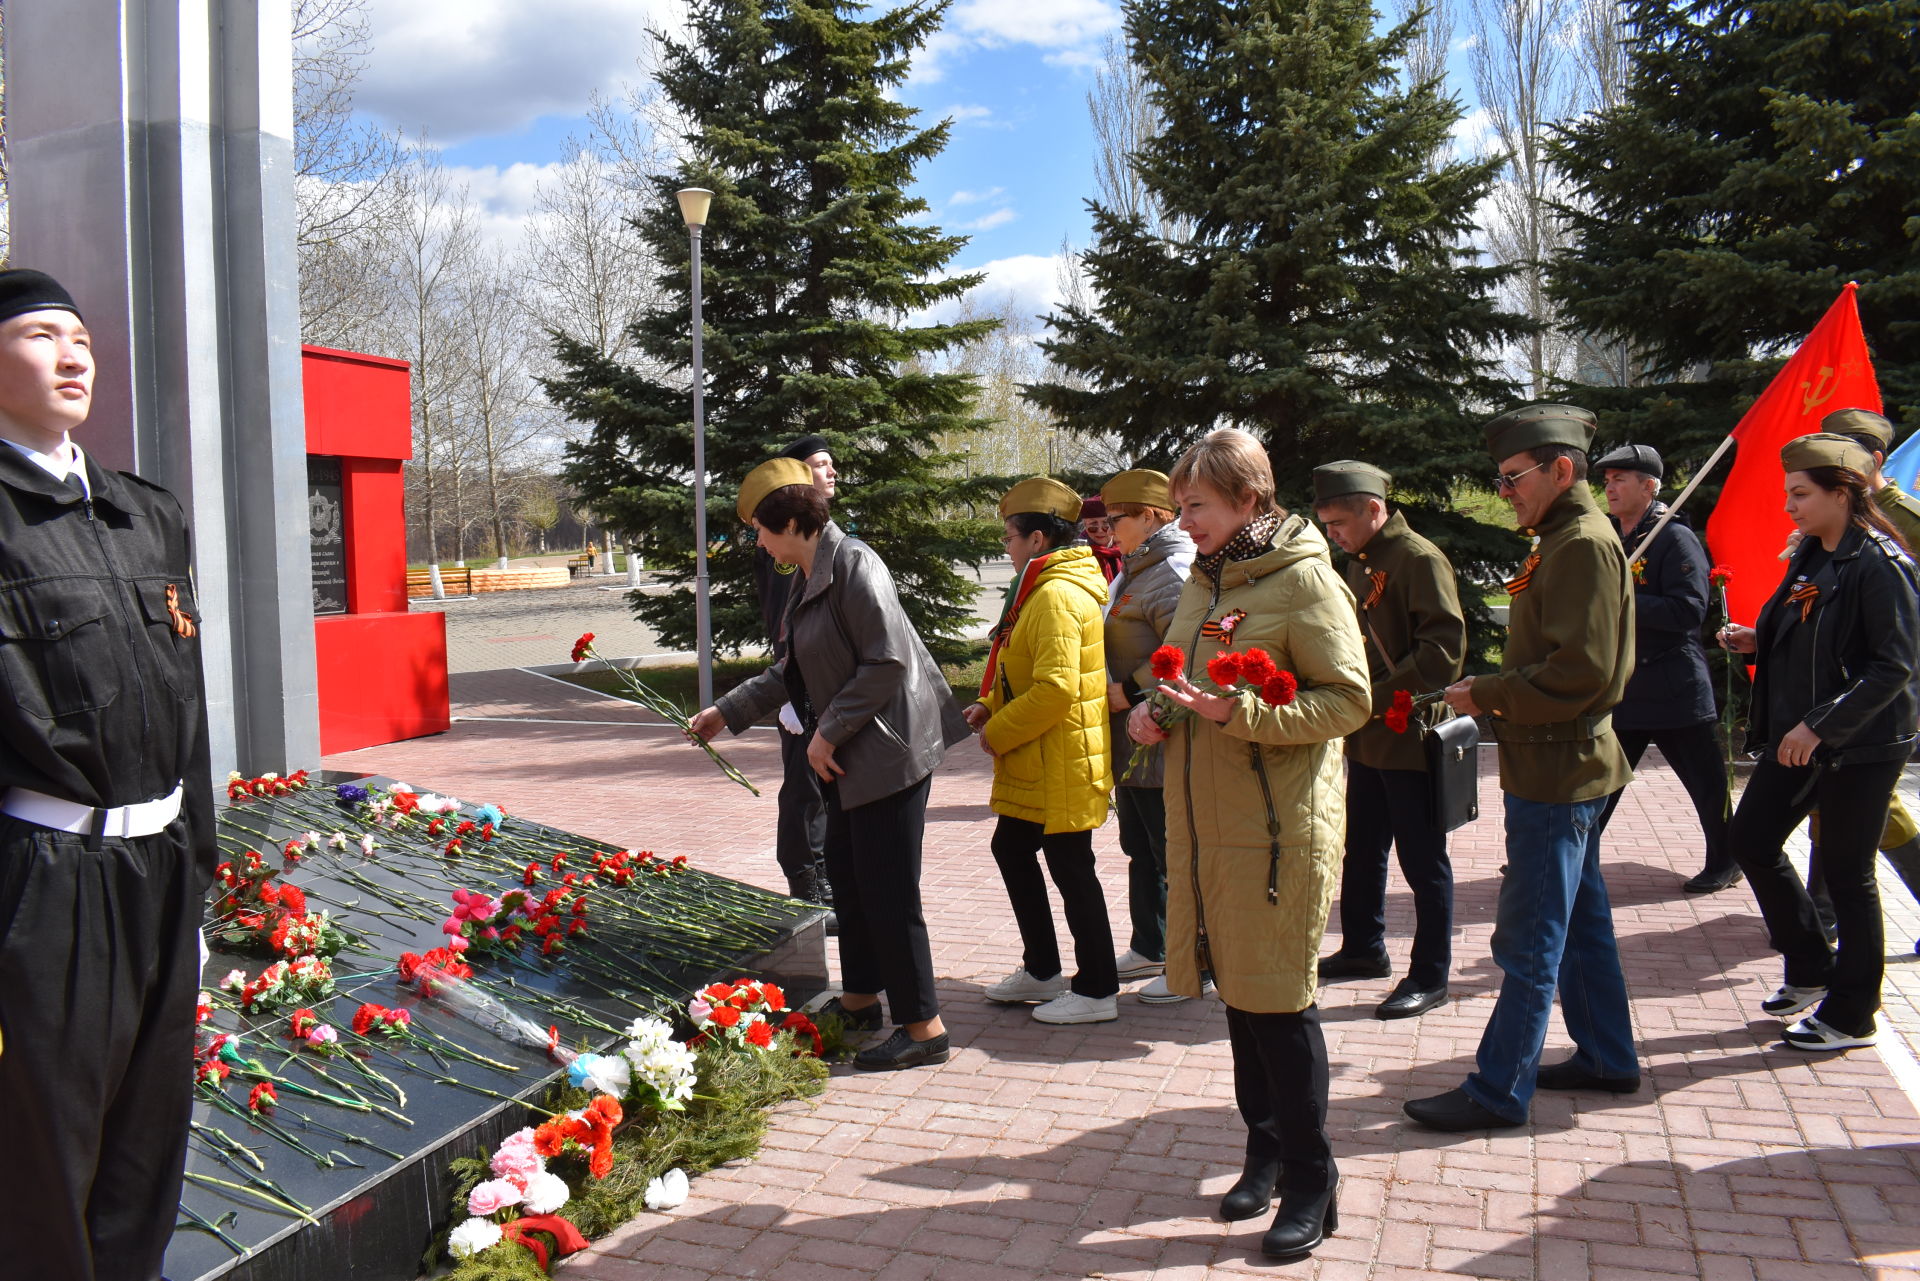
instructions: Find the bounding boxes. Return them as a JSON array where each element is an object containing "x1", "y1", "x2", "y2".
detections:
[{"x1": 1029, "y1": 0, "x2": 1532, "y2": 660}]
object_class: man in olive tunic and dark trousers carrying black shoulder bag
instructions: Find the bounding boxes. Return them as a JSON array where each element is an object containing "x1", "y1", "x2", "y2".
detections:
[{"x1": 1313, "y1": 461, "x2": 1467, "y2": 1018}]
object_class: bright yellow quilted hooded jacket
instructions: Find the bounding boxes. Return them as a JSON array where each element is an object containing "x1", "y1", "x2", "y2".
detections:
[{"x1": 981, "y1": 544, "x2": 1114, "y2": 832}]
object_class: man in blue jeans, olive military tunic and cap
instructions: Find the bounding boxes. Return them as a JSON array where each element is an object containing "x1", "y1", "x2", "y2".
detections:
[{"x1": 1405, "y1": 405, "x2": 1640, "y2": 1131}]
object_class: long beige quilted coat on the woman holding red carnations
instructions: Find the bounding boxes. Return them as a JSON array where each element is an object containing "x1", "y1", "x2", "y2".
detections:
[{"x1": 1165, "y1": 517, "x2": 1373, "y2": 1014}]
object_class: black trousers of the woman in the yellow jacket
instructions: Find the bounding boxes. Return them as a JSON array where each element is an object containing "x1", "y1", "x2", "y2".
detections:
[{"x1": 993, "y1": 814, "x2": 1119, "y2": 997}]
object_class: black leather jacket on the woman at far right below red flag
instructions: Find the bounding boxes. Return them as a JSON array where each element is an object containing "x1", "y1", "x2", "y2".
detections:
[{"x1": 1747, "y1": 528, "x2": 1920, "y2": 764}]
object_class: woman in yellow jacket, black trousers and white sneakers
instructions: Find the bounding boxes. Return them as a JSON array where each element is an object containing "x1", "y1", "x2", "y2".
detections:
[{"x1": 966, "y1": 476, "x2": 1119, "y2": 1024}]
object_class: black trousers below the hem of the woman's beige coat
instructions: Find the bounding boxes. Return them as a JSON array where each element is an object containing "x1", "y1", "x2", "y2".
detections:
[{"x1": 1227, "y1": 1004, "x2": 1334, "y2": 1196}]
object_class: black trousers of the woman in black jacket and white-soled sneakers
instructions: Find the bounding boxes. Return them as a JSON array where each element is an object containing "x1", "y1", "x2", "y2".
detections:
[{"x1": 1730, "y1": 757, "x2": 1905, "y2": 1035}]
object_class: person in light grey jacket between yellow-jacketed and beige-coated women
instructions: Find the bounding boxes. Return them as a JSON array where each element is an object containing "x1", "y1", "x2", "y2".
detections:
[{"x1": 1100, "y1": 469, "x2": 1194, "y2": 1004}]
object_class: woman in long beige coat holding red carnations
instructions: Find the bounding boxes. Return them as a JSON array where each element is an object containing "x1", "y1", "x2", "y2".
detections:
[{"x1": 1127, "y1": 428, "x2": 1371, "y2": 1258}]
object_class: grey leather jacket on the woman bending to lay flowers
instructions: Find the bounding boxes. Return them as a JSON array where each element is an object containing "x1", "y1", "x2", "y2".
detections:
[{"x1": 714, "y1": 520, "x2": 972, "y2": 809}]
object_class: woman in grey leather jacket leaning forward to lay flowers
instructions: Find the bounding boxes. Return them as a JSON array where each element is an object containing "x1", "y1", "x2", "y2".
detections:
[{"x1": 693, "y1": 459, "x2": 970, "y2": 1070}]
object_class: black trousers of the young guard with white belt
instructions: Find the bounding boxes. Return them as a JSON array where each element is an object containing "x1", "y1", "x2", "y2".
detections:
[{"x1": 0, "y1": 816, "x2": 205, "y2": 1281}]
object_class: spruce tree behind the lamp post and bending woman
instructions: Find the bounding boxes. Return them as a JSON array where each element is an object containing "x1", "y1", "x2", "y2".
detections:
[{"x1": 547, "y1": 0, "x2": 998, "y2": 655}]
